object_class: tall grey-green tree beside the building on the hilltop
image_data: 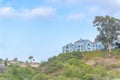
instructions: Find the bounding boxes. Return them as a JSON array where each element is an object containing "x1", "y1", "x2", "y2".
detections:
[{"x1": 93, "y1": 15, "x2": 120, "y2": 51}]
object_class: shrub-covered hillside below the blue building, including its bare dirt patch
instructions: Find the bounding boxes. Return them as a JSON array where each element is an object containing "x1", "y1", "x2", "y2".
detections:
[{"x1": 40, "y1": 49, "x2": 120, "y2": 80}]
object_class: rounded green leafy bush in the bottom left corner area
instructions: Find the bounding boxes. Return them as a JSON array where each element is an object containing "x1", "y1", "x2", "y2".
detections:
[{"x1": 7, "y1": 65, "x2": 36, "y2": 80}]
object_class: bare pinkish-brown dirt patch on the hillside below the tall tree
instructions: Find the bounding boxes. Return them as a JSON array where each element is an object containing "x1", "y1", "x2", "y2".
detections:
[{"x1": 85, "y1": 54, "x2": 120, "y2": 72}]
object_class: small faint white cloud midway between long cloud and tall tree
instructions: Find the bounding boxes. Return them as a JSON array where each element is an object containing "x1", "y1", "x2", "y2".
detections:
[{"x1": 67, "y1": 13, "x2": 84, "y2": 21}]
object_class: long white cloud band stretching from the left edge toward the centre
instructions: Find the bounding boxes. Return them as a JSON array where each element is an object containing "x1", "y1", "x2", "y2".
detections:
[{"x1": 0, "y1": 7, "x2": 55, "y2": 19}]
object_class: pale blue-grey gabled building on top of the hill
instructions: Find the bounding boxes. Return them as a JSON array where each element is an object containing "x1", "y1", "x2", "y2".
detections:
[{"x1": 62, "y1": 39, "x2": 104, "y2": 53}]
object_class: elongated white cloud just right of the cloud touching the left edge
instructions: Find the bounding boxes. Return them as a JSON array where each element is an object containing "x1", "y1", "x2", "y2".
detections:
[{"x1": 19, "y1": 7, "x2": 55, "y2": 18}]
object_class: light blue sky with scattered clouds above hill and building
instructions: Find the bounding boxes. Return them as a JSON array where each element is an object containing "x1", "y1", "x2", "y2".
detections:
[{"x1": 0, "y1": 0, "x2": 120, "y2": 62}]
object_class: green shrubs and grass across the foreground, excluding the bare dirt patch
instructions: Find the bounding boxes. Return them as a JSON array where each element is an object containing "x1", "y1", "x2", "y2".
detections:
[{"x1": 0, "y1": 49, "x2": 120, "y2": 80}]
